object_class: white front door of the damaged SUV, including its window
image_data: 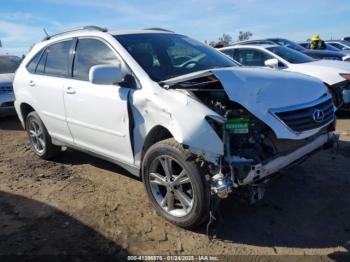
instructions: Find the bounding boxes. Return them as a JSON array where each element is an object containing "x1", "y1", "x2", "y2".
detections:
[{"x1": 64, "y1": 38, "x2": 133, "y2": 164}]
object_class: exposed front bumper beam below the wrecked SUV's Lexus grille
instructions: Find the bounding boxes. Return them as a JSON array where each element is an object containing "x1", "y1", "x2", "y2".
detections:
[{"x1": 240, "y1": 132, "x2": 339, "y2": 185}]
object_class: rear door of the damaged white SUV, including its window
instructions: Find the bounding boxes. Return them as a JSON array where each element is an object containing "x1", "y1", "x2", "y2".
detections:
[{"x1": 27, "y1": 40, "x2": 73, "y2": 143}]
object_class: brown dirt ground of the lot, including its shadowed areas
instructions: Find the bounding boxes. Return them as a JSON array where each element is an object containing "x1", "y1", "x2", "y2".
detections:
[{"x1": 0, "y1": 117, "x2": 350, "y2": 261}]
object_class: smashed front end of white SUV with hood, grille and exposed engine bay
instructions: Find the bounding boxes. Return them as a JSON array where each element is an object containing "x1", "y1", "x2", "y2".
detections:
[{"x1": 161, "y1": 69, "x2": 338, "y2": 203}]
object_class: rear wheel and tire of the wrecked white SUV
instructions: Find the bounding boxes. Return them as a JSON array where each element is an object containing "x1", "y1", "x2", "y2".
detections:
[{"x1": 26, "y1": 112, "x2": 61, "y2": 159}]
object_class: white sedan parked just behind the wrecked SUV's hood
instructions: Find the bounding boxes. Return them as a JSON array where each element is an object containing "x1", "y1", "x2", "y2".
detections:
[{"x1": 219, "y1": 45, "x2": 350, "y2": 109}]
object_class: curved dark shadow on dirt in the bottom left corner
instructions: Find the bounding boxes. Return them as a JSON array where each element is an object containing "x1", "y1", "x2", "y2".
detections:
[{"x1": 0, "y1": 191, "x2": 128, "y2": 261}]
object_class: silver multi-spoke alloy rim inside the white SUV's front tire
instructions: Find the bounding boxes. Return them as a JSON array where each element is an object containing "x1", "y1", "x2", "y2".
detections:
[{"x1": 149, "y1": 155, "x2": 195, "y2": 217}]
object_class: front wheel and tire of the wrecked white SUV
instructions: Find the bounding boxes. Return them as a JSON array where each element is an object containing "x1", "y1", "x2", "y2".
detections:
[{"x1": 142, "y1": 139, "x2": 210, "y2": 228}]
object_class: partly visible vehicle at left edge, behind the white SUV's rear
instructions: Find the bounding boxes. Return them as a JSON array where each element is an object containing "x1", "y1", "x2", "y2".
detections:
[{"x1": 0, "y1": 55, "x2": 20, "y2": 116}]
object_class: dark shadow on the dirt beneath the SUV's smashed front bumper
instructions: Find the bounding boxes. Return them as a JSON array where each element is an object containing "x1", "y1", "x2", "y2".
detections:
[{"x1": 199, "y1": 141, "x2": 350, "y2": 261}]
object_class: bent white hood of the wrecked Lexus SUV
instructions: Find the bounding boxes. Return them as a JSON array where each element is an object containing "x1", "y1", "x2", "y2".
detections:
[{"x1": 163, "y1": 67, "x2": 327, "y2": 139}]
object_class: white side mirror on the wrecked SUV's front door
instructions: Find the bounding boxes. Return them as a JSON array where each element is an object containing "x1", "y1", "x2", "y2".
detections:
[{"x1": 89, "y1": 65, "x2": 124, "y2": 85}]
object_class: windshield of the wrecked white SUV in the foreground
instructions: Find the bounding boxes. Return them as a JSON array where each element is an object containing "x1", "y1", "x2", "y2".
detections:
[{"x1": 115, "y1": 33, "x2": 238, "y2": 82}]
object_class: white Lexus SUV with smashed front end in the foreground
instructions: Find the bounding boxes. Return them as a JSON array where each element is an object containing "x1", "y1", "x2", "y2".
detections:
[{"x1": 14, "y1": 27, "x2": 337, "y2": 228}]
